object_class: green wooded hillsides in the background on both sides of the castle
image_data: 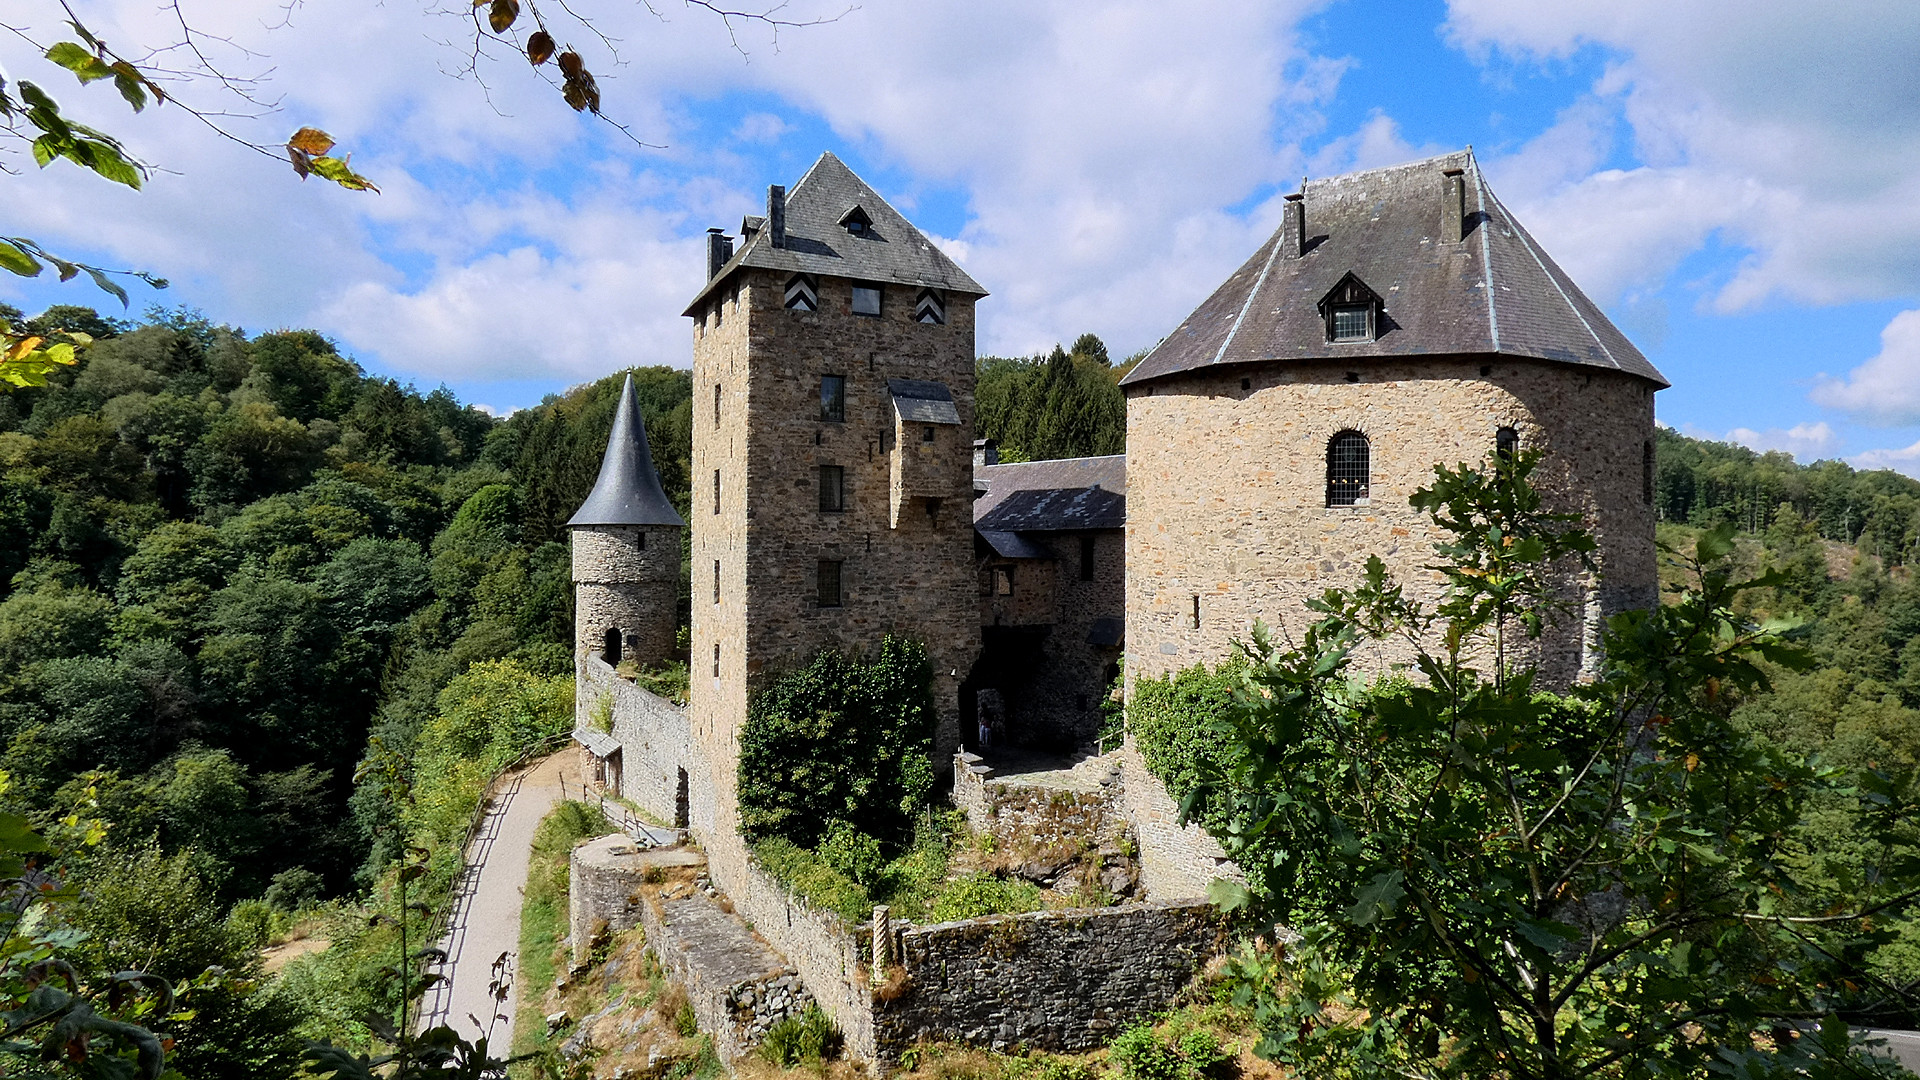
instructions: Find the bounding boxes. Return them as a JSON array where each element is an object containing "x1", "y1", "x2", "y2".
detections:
[{"x1": 0, "y1": 297, "x2": 1920, "y2": 1060}]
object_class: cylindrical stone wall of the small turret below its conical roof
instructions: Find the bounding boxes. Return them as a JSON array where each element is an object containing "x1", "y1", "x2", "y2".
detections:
[{"x1": 572, "y1": 525, "x2": 680, "y2": 667}]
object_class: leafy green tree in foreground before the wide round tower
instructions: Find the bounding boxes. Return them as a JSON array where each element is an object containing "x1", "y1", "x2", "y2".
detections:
[{"x1": 1187, "y1": 453, "x2": 1920, "y2": 1080}]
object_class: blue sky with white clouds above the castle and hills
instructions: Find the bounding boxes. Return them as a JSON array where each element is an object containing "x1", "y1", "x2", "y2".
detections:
[{"x1": 0, "y1": 0, "x2": 1920, "y2": 477}]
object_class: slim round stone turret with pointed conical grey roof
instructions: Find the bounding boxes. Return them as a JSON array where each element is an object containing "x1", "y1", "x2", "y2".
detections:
[{"x1": 566, "y1": 375, "x2": 685, "y2": 667}]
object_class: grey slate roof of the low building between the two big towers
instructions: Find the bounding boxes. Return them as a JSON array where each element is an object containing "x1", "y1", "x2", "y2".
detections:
[{"x1": 973, "y1": 454, "x2": 1127, "y2": 534}]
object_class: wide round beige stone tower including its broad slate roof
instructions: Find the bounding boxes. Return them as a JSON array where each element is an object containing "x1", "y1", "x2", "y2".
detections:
[{"x1": 1121, "y1": 152, "x2": 1667, "y2": 684}]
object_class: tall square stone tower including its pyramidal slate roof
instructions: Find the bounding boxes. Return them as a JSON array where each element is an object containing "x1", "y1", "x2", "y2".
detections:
[{"x1": 685, "y1": 154, "x2": 985, "y2": 888}]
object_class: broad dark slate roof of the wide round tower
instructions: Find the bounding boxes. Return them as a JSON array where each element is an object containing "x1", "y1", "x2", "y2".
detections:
[{"x1": 1121, "y1": 150, "x2": 1667, "y2": 386}]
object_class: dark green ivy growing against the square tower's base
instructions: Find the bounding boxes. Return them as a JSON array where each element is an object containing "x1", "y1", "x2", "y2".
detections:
[{"x1": 739, "y1": 634, "x2": 933, "y2": 851}]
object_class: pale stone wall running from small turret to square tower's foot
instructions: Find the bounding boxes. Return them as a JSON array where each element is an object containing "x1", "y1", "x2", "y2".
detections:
[{"x1": 574, "y1": 653, "x2": 708, "y2": 828}]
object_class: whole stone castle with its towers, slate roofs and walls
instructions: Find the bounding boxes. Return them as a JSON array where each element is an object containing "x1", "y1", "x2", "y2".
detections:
[{"x1": 572, "y1": 152, "x2": 1667, "y2": 1055}]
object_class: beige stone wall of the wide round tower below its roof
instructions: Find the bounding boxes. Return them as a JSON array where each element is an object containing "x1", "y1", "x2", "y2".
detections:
[{"x1": 1127, "y1": 356, "x2": 1657, "y2": 684}]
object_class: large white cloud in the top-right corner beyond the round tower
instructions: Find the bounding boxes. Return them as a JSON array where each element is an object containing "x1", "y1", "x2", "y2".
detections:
[{"x1": 1448, "y1": 0, "x2": 1920, "y2": 311}]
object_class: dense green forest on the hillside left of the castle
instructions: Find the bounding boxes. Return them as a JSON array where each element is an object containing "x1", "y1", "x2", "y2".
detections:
[{"x1": 0, "y1": 297, "x2": 689, "y2": 1078}]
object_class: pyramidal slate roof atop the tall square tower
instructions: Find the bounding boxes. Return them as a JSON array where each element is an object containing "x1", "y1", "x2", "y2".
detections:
[{"x1": 685, "y1": 154, "x2": 987, "y2": 315}]
